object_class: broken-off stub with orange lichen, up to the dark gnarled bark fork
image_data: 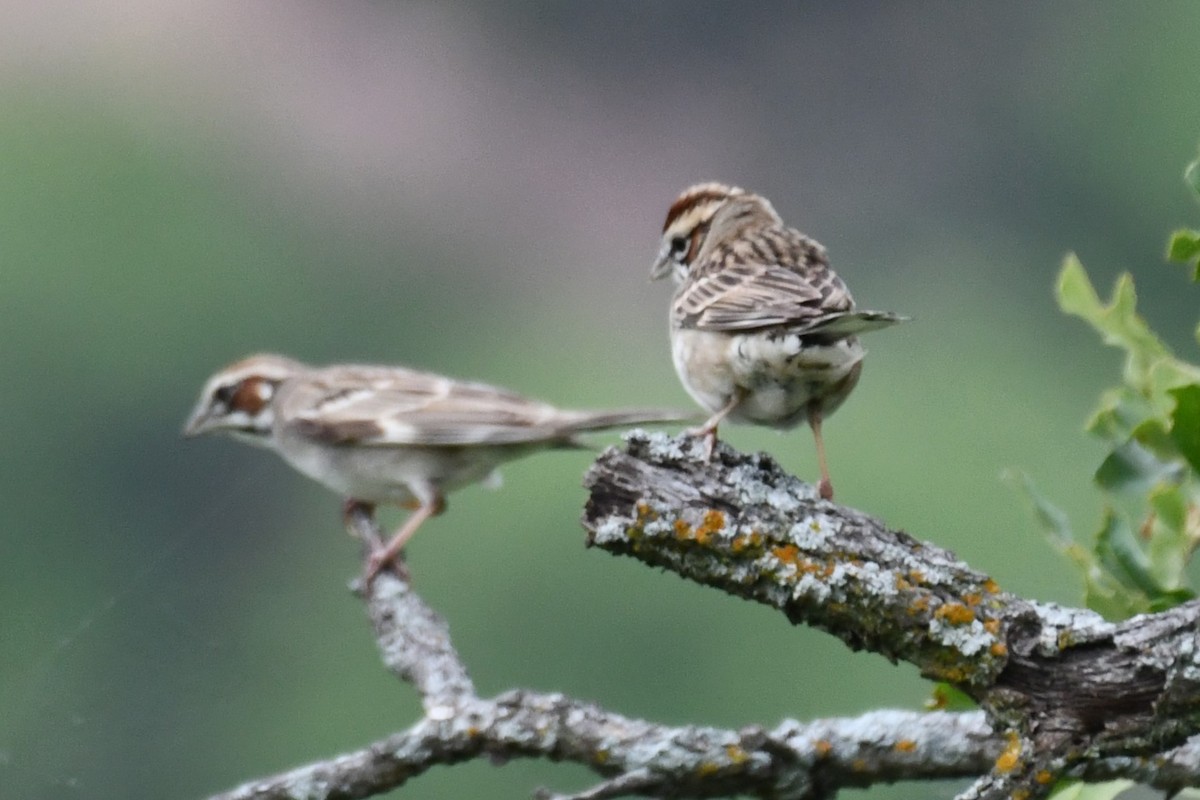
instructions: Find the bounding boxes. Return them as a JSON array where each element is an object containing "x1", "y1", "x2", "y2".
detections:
[{"x1": 583, "y1": 435, "x2": 1033, "y2": 686}]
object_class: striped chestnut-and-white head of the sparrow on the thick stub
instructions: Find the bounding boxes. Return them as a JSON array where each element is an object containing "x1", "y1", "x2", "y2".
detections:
[{"x1": 650, "y1": 184, "x2": 780, "y2": 283}]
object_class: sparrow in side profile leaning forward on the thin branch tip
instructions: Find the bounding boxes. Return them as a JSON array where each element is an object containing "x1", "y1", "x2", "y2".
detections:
[{"x1": 184, "y1": 355, "x2": 686, "y2": 581}]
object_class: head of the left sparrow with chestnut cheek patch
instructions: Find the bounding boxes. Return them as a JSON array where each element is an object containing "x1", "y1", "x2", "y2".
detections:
[{"x1": 184, "y1": 354, "x2": 306, "y2": 446}]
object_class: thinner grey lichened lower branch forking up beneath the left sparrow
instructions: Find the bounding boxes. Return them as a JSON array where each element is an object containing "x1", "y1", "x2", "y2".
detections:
[{"x1": 204, "y1": 534, "x2": 1003, "y2": 800}]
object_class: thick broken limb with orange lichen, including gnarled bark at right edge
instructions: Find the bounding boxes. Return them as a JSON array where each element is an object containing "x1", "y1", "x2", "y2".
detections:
[{"x1": 583, "y1": 432, "x2": 1200, "y2": 798}]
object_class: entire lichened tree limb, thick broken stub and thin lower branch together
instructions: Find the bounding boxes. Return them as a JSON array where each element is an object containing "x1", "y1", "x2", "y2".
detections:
[{"x1": 204, "y1": 433, "x2": 1200, "y2": 800}]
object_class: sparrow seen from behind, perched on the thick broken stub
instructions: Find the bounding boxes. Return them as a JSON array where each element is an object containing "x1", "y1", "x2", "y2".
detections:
[{"x1": 650, "y1": 184, "x2": 904, "y2": 500}]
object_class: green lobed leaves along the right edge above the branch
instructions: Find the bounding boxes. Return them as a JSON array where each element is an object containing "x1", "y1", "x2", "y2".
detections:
[{"x1": 1014, "y1": 154, "x2": 1200, "y2": 619}]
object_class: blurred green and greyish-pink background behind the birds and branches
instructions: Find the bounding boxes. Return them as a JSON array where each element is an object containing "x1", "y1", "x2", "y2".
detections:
[{"x1": 0, "y1": 0, "x2": 1200, "y2": 799}]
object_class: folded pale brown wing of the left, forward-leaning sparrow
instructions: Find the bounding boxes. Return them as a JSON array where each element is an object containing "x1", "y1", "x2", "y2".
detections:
[{"x1": 294, "y1": 368, "x2": 571, "y2": 447}]
